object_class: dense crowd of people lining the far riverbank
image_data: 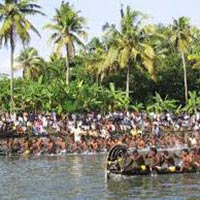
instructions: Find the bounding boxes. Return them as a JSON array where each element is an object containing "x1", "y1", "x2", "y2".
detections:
[{"x1": 0, "y1": 111, "x2": 200, "y2": 155}]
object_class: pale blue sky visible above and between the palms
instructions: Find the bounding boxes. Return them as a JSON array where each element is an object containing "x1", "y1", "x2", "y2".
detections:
[{"x1": 0, "y1": 0, "x2": 200, "y2": 73}]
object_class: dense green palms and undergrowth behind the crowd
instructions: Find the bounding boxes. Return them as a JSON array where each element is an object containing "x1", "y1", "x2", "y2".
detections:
[{"x1": 0, "y1": 0, "x2": 200, "y2": 113}]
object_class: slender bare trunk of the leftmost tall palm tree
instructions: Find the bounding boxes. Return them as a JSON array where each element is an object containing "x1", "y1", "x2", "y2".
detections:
[{"x1": 10, "y1": 31, "x2": 15, "y2": 114}]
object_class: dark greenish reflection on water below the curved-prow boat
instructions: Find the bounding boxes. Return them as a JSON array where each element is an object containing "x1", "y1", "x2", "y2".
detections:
[{"x1": 107, "y1": 174, "x2": 200, "y2": 200}]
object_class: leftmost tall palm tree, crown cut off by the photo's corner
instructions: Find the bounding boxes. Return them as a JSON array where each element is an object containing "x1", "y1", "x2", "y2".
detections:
[{"x1": 0, "y1": 0, "x2": 44, "y2": 113}]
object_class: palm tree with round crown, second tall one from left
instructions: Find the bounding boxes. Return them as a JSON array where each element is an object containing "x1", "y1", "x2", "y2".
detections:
[{"x1": 45, "y1": 1, "x2": 86, "y2": 85}]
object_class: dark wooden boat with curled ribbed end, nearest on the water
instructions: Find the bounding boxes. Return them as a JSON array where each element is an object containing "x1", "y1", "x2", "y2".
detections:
[{"x1": 106, "y1": 145, "x2": 199, "y2": 179}]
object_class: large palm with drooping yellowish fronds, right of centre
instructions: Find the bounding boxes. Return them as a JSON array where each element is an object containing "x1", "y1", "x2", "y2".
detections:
[{"x1": 104, "y1": 6, "x2": 155, "y2": 97}]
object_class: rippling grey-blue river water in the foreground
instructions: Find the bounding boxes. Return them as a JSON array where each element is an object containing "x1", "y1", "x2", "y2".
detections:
[{"x1": 0, "y1": 155, "x2": 200, "y2": 200}]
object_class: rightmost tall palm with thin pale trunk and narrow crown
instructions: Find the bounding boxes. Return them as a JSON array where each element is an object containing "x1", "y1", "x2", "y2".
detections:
[{"x1": 171, "y1": 17, "x2": 192, "y2": 103}]
